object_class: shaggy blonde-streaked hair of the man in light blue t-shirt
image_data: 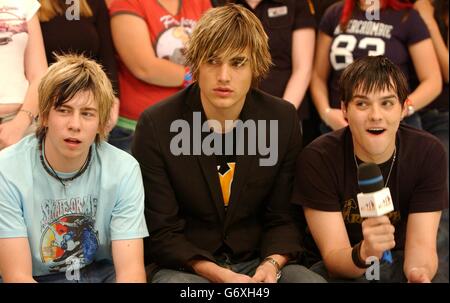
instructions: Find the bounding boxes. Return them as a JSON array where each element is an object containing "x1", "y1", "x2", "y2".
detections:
[{"x1": 36, "y1": 54, "x2": 114, "y2": 143}]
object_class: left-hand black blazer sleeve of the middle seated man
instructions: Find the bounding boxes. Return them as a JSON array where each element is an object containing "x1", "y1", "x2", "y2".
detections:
[{"x1": 132, "y1": 111, "x2": 214, "y2": 269}]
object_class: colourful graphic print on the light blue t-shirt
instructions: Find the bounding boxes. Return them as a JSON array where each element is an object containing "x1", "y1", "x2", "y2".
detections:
[{"x1": 40, "y1": 196, "x2": 99, "y2": 272}]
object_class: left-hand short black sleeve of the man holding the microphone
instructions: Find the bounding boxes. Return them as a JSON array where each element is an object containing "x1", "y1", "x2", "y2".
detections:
[{"x1": 291, "y1": 147, "x2": 341, "y2": 211}]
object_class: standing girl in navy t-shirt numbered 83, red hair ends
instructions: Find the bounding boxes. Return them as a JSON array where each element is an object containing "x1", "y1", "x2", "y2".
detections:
[{"x1": 311, "y1": 0, "x2": 442, "y2": 132}]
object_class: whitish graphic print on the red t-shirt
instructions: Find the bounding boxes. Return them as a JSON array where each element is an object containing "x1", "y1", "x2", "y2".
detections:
[{"x1": 155, "y1": 15, "x2": 196, "y2": 65}]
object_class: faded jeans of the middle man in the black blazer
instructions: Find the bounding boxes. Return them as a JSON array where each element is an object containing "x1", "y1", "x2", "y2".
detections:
[{"x1": 151, "y1": 259, "x2": 326, "y2": 283}]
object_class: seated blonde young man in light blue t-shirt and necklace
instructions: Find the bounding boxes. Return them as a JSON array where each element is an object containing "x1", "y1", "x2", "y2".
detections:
[{"x1": 0, "y1": 55, "x2": 148, "y2": 282}]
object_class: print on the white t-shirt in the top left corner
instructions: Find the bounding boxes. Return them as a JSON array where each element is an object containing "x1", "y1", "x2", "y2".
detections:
[{"x1": 0, "y1": 5, "x2": 28, "y2": 46}]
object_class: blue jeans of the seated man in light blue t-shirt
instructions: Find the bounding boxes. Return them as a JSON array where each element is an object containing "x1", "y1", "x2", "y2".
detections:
[{"x1": 0, "y1": 260, "x2": 116, "y2": 283}]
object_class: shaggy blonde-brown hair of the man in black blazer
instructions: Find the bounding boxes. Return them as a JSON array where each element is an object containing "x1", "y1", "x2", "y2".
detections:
[{"x1": 186, "y1": 4, "x2": 272, "y2": 85}]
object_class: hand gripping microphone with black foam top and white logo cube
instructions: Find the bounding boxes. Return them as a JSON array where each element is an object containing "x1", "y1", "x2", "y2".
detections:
[{"x1": 357, "y1": 163, "x2": 395, "y2": 264}]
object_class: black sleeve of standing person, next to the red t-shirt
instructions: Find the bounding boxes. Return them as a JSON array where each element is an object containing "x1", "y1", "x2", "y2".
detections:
[{"x1": 90, "y1": 0, "x2": 119, "y2": 96}]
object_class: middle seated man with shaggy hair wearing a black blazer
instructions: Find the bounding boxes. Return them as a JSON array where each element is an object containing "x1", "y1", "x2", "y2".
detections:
[{"x1": 132, "y1": 5, "x2": 324, "y2": 282}]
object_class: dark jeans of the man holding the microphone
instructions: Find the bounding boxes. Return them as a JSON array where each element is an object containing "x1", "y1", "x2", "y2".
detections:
[{"x1": 309, "y1": 251, "x2": 448, "y2": 283}]
